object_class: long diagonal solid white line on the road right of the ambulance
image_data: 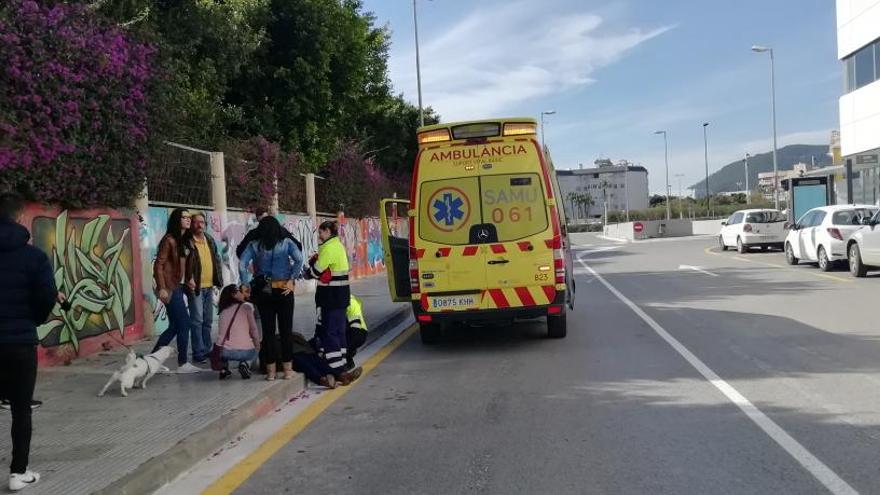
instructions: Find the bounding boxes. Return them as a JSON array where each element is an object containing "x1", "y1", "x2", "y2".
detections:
[{"x1": 578, "y1": 257, "x2": 858, "y2": 495}]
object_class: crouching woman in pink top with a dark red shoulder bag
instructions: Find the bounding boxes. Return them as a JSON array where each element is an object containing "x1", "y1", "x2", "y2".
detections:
[{"x1": 217, "y1": 284, "x2": 260, "y2": 380}]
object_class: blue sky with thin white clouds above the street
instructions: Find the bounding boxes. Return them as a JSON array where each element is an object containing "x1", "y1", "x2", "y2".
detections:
[{"x1": 364, "y1": 0, "x2": 843, "y2": 194}]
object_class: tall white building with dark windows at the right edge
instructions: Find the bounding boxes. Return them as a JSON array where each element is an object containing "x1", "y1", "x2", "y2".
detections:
[{"x1": 837, "y1": 0, "x2": 880, "y2": 204}]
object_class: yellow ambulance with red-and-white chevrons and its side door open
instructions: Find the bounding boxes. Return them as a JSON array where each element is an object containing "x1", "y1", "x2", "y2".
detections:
[{"x1": 381, "y1": 118, "x2": 575, "y2": 344}]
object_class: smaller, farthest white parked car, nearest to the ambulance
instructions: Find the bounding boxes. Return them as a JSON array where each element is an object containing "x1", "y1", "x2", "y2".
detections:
[{"x1": 718, "y1": 209, "x2": 785, "y2": 253}]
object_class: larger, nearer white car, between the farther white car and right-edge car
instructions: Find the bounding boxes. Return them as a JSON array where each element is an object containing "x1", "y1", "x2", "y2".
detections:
[{"x1": 785, "y1": 205, "x2": 878, "y2": 272}]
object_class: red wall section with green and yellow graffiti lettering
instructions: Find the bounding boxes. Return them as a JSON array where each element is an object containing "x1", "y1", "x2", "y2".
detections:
[{"x1": 22, "y1": 205, "x2": 144, "y2": 365}]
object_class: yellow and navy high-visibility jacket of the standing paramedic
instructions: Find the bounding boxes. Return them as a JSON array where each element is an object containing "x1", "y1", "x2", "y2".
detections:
[{"x1": 311, "y1": 236, "x2": 351, "y2": 309}]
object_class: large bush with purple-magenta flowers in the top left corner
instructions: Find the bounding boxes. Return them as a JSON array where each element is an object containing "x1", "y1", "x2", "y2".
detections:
[{"x1": 0, "y1": 0, "x2": 155, "y2": 207}]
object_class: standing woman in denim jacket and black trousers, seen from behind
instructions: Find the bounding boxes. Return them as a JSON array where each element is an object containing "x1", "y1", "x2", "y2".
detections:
[{"x1": 239, "y1": 216, "x2": 303, "y2": 381}]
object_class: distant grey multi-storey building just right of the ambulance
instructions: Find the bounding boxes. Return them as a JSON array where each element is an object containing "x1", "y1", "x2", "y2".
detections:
[{"x1": 556, "y1": 160, "x2": 648, "y2": 223}]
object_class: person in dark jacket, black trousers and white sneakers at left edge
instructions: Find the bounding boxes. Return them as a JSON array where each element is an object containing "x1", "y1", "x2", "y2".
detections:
[{"x1": 0, "y1": 193, "x2": 61, "y2": 491}]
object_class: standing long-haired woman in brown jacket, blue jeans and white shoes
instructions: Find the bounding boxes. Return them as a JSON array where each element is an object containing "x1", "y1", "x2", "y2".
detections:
[{"x1": 153, "y1": 208, "x2": 200, "y2": 373}]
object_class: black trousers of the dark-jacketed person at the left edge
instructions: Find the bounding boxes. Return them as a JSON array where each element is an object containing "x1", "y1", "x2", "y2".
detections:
[{"x1": 0, "y1": 344, "x2": 37, "y2": 474}]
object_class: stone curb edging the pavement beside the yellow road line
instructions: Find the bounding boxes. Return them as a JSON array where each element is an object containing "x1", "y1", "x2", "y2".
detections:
[{"x1": 93, "y1": 306, "x2": 410, "y2": 495}]
